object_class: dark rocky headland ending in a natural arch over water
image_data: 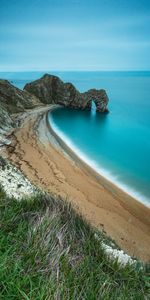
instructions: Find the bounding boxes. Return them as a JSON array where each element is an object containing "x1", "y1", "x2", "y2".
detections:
[{"x1": 24, "y1": 74, "x2": 108, "y2": 112}]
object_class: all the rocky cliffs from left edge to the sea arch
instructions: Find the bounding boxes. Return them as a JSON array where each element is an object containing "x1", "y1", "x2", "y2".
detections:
[{"x1": 0, "y1": 74, "x2": 108, "y2": 145}]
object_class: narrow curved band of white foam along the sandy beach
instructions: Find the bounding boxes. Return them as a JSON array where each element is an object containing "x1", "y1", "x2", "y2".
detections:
[{"x1": 49, "y1": 114, "x2": 150, "y2": 208}]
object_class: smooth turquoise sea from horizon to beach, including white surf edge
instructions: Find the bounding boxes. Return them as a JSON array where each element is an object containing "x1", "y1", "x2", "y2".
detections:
[{"x1": 0, "y1": 71, "x2": 150, "y2": 207}]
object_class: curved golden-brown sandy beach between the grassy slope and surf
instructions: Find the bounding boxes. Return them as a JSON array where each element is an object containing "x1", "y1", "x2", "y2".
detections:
[{"x1": 5, "y1": 105, "x2": 150, "y2": 261}]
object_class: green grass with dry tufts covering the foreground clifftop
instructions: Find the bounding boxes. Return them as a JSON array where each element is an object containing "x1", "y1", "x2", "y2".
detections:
[{"x1": 0, "y1": 188, "x2": 150, "y2": 300}]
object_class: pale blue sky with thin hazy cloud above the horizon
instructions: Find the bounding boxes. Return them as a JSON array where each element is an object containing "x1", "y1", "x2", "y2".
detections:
[{"x1": 0, "y1": 0, "x2": 150, "y2": 71}]
